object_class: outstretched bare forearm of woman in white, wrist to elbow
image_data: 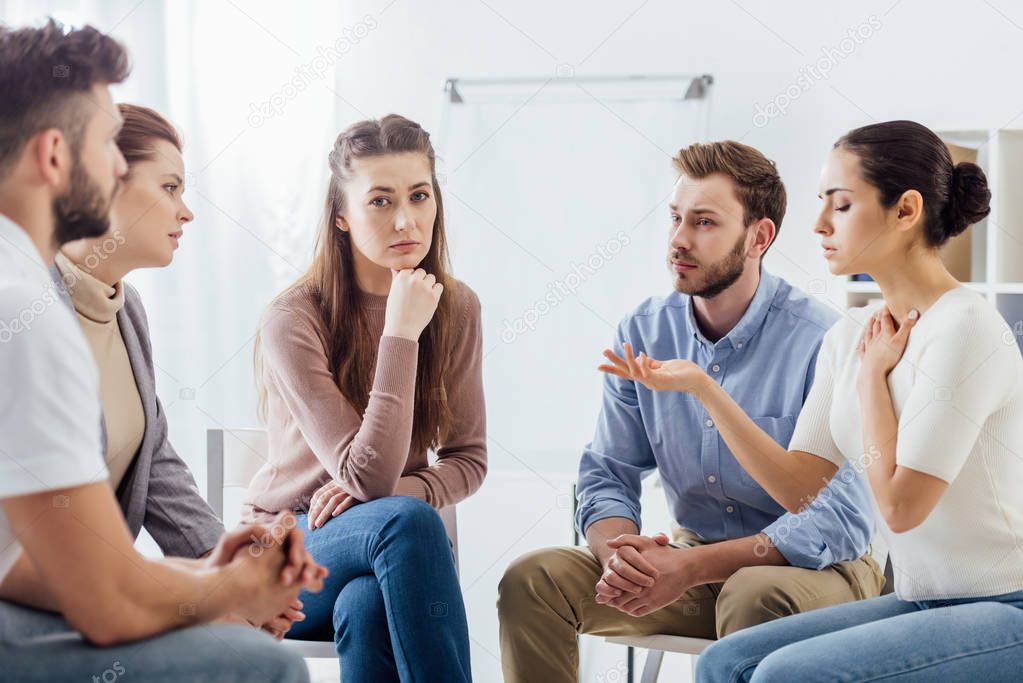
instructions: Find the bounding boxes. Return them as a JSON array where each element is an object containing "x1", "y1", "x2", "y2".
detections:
[{"x1": 695, "y1": 375, "x2": 838, "y2": 512}]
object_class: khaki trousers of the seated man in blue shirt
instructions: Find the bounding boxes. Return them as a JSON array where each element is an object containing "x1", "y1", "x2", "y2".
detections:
[{"x1": 497, "y1": 530, "x2": 885, "y2": 683}]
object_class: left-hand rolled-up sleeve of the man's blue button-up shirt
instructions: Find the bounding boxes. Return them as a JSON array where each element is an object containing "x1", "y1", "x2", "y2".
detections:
[{"x1": 576, "y1": 325, "x2": 657, "y2": 535}]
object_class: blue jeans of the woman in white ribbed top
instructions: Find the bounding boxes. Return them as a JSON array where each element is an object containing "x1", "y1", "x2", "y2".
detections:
[{"x1": 697, "y1": 591, "x2": 1023, "y2": 683}]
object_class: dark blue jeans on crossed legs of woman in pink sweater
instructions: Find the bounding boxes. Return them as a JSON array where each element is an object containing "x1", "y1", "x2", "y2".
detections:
[{"x1": 287, "y1": 496, "x2": 472, "y2": 683}]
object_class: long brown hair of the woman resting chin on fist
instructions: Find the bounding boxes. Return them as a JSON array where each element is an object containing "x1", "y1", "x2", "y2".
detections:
[{"x1": 255, "y1": 113, "x2": 456, "y2": 450}]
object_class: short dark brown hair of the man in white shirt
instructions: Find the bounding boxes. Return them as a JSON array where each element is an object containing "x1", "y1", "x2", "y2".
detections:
[{"x1": 0, "y1": 19, "x2": 131, "y2": 177}]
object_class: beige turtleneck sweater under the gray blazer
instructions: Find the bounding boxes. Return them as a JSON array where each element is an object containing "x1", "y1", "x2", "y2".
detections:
[{"x1": 56, "y1": 253, "x2": 145, "y2": 491}]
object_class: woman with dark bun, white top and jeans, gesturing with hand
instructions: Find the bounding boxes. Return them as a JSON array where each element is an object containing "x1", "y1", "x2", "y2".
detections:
[{"x1": 597, "y1": 121, "x2": 1023, "y2": 683}]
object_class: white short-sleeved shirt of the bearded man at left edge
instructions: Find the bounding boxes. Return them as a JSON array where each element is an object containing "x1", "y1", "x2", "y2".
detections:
[{"x1": 0, "y1": 214, "x2": 107, "y2": 579}]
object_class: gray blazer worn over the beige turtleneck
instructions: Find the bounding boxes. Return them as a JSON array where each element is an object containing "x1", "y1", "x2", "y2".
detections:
[{"x1": 51, "y1": 267, "x2": 224, "y2": 557}]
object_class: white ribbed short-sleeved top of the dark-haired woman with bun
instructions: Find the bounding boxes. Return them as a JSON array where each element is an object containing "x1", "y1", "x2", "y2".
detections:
[{"x1": 790, "y1": 287, "x2": 1023, "y2": 600}]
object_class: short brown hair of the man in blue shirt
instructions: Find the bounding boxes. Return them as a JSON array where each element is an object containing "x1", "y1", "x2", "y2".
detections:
[{"x1": 671, "y1": 140, "x2": 786, "y2": 252}]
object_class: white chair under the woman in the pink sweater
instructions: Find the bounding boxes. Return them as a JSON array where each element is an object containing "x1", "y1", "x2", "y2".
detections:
[{"x1": 206, "y1": 429, "x2": 458, "y2": 659}]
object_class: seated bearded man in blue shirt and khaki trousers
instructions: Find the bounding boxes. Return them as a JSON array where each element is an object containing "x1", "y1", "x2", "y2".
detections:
[{"x1": 498, "y1": 141, "x2": 884, "y2": 683}]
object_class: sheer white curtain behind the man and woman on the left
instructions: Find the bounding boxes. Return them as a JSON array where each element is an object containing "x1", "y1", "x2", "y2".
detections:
[{"x1": 0, "y1": 0, "x2": 346, "y2": 501}]
